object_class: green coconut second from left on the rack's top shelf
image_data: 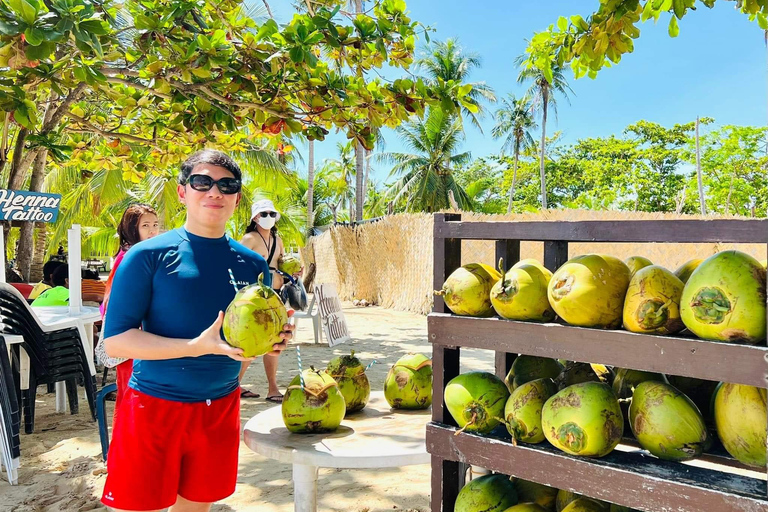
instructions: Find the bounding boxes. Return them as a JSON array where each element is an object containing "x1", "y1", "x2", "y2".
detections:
[{"x1": 491, "y1": 260, "x2": 555, "y2": 322}]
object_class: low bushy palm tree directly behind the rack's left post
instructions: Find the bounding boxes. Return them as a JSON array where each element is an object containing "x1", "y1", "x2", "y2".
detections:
[{"x1": 379, "y1": 108, "x2": 472, "y2": 212}]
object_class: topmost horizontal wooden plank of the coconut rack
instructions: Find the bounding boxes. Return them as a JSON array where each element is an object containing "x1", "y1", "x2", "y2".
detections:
[{"x1": 435, "y1": 219, "x2": 768, "y2": 243}]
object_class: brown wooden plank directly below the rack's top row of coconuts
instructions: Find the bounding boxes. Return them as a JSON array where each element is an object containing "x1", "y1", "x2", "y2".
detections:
[{"x1": 427, "y1": 313, "x2": 768, "y2": 387}]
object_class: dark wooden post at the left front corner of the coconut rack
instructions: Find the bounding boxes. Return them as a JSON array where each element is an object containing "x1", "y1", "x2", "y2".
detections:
[{"x1": 430, "y1": 213, "x2": 464, "y2": 512}]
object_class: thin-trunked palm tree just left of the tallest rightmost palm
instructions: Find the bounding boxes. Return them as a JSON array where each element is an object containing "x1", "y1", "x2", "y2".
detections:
[{"x1": 491, "y1": 94, "x2": 536, "y2": 215}]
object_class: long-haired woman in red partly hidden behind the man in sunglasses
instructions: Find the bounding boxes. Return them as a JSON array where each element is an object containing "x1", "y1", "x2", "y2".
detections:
[{"x1": 96, "y1": 203, "x2": 160, "y2": 412}]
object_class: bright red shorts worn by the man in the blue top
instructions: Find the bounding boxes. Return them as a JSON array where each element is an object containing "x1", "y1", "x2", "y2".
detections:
[{"x1": 101, "y1": 388, "x2": 240, "y2": 510}]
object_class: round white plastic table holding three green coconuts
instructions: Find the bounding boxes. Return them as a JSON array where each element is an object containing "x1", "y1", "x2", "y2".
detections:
[{"x1": 243, "y1": 391, "x2": 431, "y2": 512}]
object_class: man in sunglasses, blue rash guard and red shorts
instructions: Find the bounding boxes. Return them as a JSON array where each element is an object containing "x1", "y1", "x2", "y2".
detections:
[{"x1": 101, "y1": 150, "x2": 293, "y2": 512}]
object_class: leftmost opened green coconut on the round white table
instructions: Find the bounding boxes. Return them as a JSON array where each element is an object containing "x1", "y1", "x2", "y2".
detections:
[{"x1": 282, "y1": 368, "x2": 346, "y2": 434}]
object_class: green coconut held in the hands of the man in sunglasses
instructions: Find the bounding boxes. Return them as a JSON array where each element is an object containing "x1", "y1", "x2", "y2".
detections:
[{"x1": 222, "y1": 274, "x2": 288, "y2": 357}]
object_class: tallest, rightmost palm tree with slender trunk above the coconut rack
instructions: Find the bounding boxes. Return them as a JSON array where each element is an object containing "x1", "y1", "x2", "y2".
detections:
[{"x1": 516, "y1": 60, "x2": 573, "y2": 209}]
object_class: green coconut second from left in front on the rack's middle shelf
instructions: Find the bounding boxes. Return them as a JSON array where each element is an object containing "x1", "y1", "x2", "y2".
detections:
[{"x1": 504, "y1": 379, "x2": 557, "y2": 444}]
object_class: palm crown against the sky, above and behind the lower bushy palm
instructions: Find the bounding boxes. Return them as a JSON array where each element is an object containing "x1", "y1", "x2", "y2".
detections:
[{"x1": 417, "y1": 38, "x2": 496, "y2": 133}]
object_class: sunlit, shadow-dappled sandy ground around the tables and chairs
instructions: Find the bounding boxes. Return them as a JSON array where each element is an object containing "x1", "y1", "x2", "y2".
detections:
[{"x1": 0, "y1": 304, "x2": 493, "y2": 512}]
